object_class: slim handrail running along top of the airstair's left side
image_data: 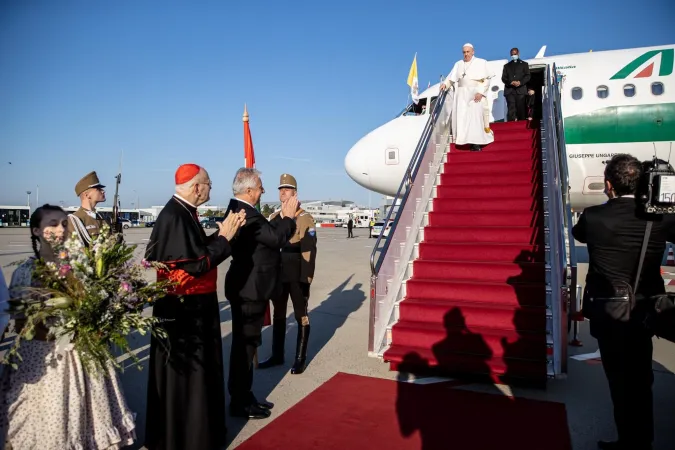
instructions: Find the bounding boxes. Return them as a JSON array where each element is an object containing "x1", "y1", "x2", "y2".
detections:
[{"x1": 370, "y1": 90, "x2": 448, "y2": 276}]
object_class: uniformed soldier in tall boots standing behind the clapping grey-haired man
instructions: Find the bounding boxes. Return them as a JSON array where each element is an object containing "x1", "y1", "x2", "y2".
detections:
[{"x1": 258, "y1": 173, "x2": 316, "y2": 374}]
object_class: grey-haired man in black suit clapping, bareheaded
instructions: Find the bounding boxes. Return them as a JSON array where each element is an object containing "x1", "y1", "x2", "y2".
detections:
[{"x1": 225, "y1": 168, "x2": 298, "y2": 419}]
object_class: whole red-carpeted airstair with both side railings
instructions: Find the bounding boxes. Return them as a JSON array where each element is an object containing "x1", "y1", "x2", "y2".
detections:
[{"x1": 368, "y1": 65, "x2": 578, "y2": 383}]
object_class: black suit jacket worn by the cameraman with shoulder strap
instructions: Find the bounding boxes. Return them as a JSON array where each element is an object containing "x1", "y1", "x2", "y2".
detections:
[{"x1": 572, "y1": 197, "x2": 675, "y2": 297}]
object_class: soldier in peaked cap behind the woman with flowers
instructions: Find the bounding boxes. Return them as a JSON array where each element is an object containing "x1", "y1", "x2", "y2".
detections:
[{"x1": 68, "y1": 172, "x2": 110, "y2": 246}]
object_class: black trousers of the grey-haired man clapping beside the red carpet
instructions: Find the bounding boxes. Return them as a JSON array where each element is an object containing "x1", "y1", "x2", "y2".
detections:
[{"x1": 227, "y1": 298, "x2": 267, "y2": 407}]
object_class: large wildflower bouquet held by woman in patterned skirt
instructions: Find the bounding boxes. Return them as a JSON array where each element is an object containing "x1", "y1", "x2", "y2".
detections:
[{"x1": 3, "y1": 225, "x2": 172, "y2": 373}]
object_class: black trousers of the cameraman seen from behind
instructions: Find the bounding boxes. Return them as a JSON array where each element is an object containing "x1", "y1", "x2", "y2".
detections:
[{"x1": 598, "y1": 324, "x2": 654, "y2": 448}]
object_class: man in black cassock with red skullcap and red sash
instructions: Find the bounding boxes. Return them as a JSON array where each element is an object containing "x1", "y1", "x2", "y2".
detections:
[{"x1": 145, "y1": 164, "x2": 244, "y2": 450}]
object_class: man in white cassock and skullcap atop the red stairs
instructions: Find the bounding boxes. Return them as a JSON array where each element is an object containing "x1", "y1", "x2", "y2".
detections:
[{"x1": 441, "y1": 44, "x2": 495, "y2": 151}]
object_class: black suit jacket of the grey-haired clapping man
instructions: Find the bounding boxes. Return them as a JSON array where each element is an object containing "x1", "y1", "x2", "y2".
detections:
[{"x1": 225, "y1": 199, "x2": 295, "y2": 301}]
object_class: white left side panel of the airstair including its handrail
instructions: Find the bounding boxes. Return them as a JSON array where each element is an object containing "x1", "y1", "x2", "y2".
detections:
[{"x1": 368, "y1": 91, "x2": 452, "y2": 357}]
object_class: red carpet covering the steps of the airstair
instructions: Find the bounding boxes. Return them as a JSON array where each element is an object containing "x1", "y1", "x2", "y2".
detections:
[{"x1": 384, "y1": 121, "x2": 547, "y2": 383}]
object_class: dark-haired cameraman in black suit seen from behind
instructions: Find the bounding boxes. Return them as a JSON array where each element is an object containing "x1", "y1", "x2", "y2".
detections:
[{"x1": 572, "y1": 154, "x2": 675, "y2": 450}]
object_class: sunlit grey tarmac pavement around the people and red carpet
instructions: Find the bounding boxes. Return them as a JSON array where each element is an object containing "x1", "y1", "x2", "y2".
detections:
[{"x1": 0, "y1": 228, "x2": 675, "y2": 450}]
